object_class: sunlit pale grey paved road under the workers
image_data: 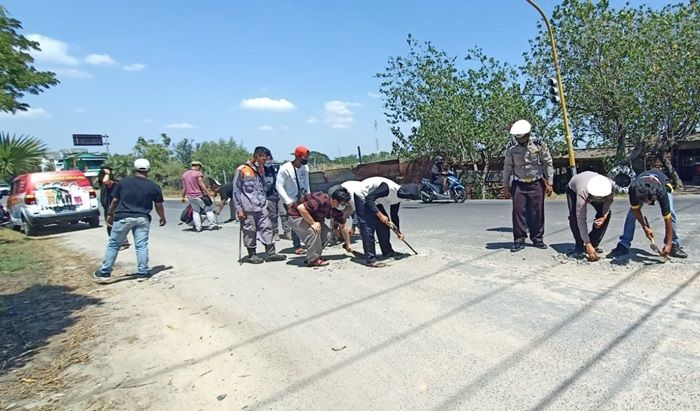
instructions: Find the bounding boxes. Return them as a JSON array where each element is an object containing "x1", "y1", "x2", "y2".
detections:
[{"x1": 60, "y1": 196, "x2": 700, "y2": 409}]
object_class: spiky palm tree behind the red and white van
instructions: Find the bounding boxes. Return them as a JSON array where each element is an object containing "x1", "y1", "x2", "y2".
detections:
[{"x1": 0, "y1": 132, "x2": 46, "y2": 178}]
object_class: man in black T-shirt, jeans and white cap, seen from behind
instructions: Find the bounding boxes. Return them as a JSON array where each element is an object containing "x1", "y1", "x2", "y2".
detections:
[{"x1": 93, "y1": 158, "x2": 165, "y2": 281}]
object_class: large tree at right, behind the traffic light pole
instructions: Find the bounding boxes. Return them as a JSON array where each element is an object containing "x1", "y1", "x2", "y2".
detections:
[{"x1": 525, "y1": 0, "x2": 700, "y2": 185}]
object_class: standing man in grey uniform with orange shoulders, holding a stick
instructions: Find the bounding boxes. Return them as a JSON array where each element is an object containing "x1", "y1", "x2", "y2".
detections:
[{"x1": 233, "y1": 147, "x2": 287, "y2": 264}]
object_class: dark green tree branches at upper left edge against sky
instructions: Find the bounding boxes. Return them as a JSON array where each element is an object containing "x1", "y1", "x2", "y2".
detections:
[{"x1": 0, "y1": 5, "x2": 59, "y2": 113}]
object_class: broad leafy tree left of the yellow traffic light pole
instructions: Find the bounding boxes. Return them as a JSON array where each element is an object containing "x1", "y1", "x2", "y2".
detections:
[{"x1": 377, "y1": 36, "x2": 553, "y2": 197}]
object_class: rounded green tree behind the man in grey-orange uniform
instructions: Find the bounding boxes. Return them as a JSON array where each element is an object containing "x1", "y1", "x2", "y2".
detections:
[{"x1": 192, "y1": 138, "x2": 251, "y2": 181}]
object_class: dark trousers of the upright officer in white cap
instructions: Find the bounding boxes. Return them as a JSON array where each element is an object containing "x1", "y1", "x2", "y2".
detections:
[{"x1": 511, "y1": 179, "x2": 544, "y2": 243}]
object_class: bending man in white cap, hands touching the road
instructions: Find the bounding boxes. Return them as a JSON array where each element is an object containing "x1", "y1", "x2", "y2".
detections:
[{"x1": 566, "y1": 171, "x2": 614, "y2": 261}]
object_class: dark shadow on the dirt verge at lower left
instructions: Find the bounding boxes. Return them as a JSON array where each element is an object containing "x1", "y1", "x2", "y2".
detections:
[{"x1": 0, "y1": 285, "x2": 102, "y2": 375}]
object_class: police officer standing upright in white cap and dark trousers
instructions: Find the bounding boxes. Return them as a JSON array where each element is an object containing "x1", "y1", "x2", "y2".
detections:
[{"x1": 503, "y1": 120, "x2": 554, "y2": 252}]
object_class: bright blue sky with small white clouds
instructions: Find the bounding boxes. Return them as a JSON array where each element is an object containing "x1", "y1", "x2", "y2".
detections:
[{"x1": 0, "y1": 0, "x2": 668, "y2": 159}]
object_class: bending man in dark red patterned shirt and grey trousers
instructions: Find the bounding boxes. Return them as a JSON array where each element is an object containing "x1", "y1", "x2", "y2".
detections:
[{"x1": 289, "y1": 187, "x2": 351, "y2": 267}]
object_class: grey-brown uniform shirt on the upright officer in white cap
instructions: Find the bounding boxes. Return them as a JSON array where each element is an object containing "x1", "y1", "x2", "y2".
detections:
[{"x1": 503, "y1": 138, "x2": 554, "y2": 187}]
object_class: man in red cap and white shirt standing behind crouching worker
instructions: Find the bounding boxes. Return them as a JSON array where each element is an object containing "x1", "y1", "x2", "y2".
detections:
[{"x1": 275, "y1": 146, "x2": 311, "y2": 254}]
